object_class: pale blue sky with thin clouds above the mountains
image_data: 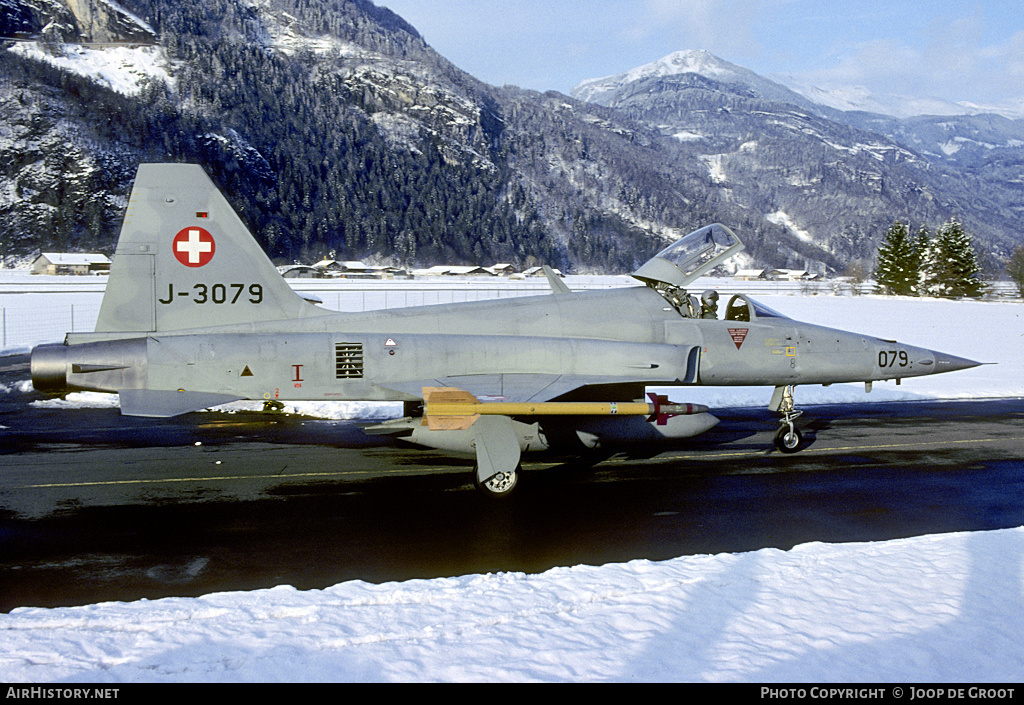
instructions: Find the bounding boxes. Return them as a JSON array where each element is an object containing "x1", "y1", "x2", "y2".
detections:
[{"x1": 376, "y1": 0, "x2": 1024, "y2": 108}]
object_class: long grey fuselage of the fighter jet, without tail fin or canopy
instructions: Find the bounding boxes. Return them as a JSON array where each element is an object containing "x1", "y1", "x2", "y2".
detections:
[{"x1": 39, "y1": 287, "x2": 956, "y2": 409}]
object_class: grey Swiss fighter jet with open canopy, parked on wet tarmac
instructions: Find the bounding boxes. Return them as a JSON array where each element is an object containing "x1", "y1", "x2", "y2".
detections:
[{"x1": 32, "y1": 164, "x2": 979, "y2": 496}]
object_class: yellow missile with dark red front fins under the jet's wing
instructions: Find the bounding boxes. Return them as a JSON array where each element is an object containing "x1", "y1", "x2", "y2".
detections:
[{"x1": 423, "y1": 386, "x2": 708, "y2": 430}]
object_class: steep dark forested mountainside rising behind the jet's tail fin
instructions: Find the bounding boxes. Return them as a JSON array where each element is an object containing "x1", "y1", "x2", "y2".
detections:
[{"x1": 0, "y1": 0, "x2": 823, "y2": 272}]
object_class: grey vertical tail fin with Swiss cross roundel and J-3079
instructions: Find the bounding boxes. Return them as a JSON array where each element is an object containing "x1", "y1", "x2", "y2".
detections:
[{"x1": 96, "y1": 164, "x2": 325, "y2": 332}]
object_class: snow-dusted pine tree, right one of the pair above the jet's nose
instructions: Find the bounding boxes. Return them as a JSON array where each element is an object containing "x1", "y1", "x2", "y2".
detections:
[{"x1": 921, "y1": 216, "x2": 981, "y2": 298}]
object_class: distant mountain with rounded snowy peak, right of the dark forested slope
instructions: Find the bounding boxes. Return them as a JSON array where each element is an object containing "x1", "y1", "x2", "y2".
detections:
[{"x1": 572, "y1": 51, "x2": 1024, "y2": 270}]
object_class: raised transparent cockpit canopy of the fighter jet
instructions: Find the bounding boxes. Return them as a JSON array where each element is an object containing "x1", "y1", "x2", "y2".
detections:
[{"x1": 633, "y1": 223, "x2": 744, "y2": 288}]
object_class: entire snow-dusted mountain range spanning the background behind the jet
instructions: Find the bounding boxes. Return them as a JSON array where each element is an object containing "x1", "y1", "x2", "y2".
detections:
[{"x1": 0, "y1": 5, "x2": 1024, "y2": 273}]
